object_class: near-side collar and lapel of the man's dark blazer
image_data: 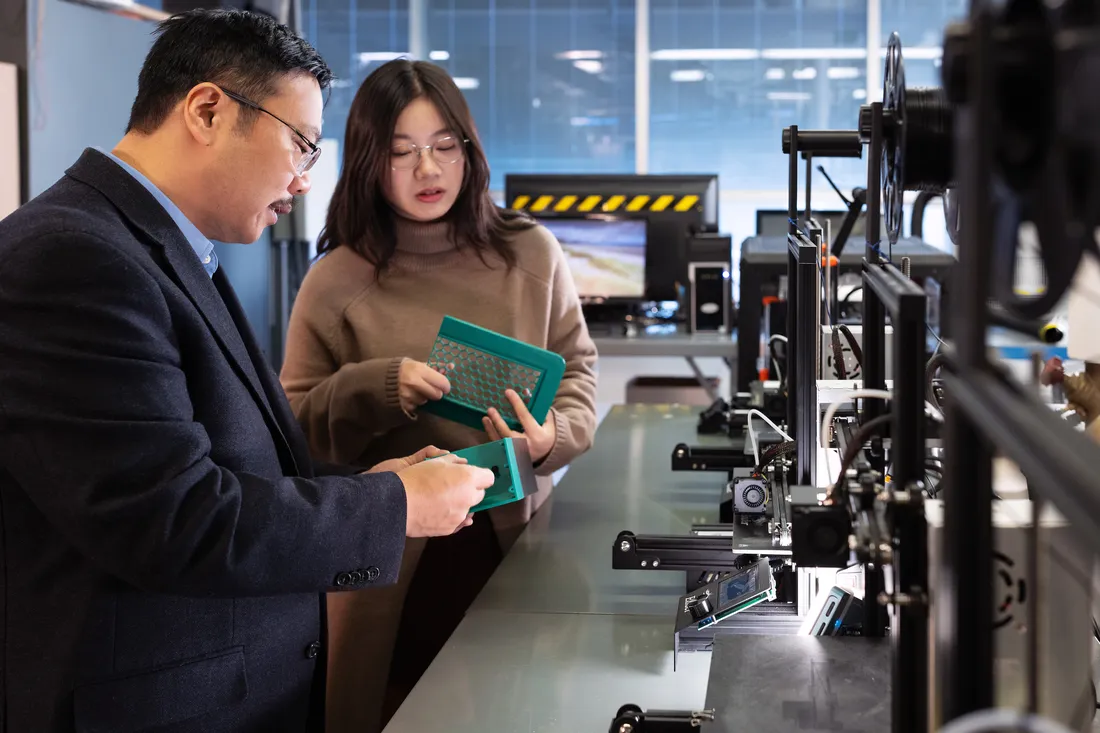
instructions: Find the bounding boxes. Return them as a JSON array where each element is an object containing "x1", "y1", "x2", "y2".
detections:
[{"x1": 66, "y1": 150, "x2": 298, "y2": 475}]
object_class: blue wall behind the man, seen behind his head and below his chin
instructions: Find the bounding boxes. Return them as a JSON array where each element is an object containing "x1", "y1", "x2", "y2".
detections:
[{"x1": 26, "y1": 0, "x2": 271, "y2": 351}]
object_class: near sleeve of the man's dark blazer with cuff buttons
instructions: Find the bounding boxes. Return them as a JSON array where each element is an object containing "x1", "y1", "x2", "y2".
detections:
[{"x1": 0, "y1": 233, "x2": 406, "y2": 595}]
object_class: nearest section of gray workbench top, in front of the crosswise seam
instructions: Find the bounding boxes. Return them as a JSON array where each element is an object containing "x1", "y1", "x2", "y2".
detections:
[{"x1": 386, "y1": 611, "x2": 711, "y2": 733}]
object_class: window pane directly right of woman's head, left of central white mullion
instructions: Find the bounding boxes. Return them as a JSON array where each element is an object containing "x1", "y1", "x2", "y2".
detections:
[{"x1": 427, "y1": 0, "x2": 635, "y2": 190}]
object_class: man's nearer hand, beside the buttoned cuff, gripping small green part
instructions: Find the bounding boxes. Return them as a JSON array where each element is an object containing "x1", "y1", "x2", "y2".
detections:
[{"x1": 397, "y1": 455, "x2": 496, "y2": 537}]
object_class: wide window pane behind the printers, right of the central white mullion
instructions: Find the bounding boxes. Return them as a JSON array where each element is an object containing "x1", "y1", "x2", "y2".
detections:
[{"x1": 649, "y1": 0, "x2": 867, "y2": 277}]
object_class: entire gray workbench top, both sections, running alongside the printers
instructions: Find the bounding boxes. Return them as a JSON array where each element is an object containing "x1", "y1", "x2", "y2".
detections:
[{"x1": 386, "y1": 405, "x2": 724, "y2": 733}]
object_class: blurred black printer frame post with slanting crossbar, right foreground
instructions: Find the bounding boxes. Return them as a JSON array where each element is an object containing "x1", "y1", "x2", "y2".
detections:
[{"x1": 936, "y1": 0, "x2": 1100, "y2": 721}]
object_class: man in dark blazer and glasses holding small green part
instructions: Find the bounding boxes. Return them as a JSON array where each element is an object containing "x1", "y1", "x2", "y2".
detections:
[{"x1": 0, "y1": 11, "x2": 493, "y2": 733}]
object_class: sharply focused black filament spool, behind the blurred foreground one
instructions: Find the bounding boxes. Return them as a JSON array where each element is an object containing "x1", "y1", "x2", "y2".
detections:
[{"x1": 881, "y1": 33, "x2": 955, "y2": 244}]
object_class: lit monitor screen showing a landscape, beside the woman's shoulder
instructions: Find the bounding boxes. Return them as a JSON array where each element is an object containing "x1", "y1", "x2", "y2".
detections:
[{"x1": 540, "y1": 218, "x2": 646, "y2": 299}]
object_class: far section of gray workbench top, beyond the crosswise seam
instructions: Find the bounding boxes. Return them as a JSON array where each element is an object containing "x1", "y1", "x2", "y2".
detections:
[{"x1": 472, "y1": 405, "x2": 729, "y2": 611}]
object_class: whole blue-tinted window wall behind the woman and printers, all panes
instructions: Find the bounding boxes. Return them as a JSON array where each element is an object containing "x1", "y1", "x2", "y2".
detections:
[{"x1": 304, "y1": 0, "x2": 967, "y2": 244}]
